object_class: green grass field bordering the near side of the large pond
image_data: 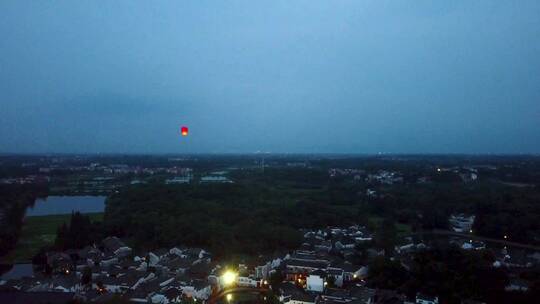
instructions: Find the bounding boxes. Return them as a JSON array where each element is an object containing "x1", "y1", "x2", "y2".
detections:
[{"x1": 1, "y1": 212, "x2": 103, "y2": 264}]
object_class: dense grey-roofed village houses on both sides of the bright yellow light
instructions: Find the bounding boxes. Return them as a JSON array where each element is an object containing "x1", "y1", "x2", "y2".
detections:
[{"x1": 0, "y1": 226, "x2": 375, "y2": 304}]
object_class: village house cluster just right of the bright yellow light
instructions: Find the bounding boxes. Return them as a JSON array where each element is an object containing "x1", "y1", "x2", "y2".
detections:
[{"x1": 255, "y1": 225, "x2": 439, "y2": 304}]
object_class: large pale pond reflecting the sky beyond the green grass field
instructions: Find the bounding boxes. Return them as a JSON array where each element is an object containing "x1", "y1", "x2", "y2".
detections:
[{"x1": 26, "y1": 196, "x2": 107, "y2": 216}]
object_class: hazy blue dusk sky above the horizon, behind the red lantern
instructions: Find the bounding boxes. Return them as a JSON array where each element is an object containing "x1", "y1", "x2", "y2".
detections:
[{"x1": 0, "y1": 0, "x2": 540, "y2": 153}]
